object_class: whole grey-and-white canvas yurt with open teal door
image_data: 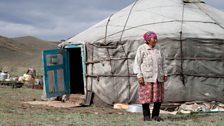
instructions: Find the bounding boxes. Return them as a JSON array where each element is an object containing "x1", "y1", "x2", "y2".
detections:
[{"x1": 43, "y1": 0, "x2": 224, "y2": 105}]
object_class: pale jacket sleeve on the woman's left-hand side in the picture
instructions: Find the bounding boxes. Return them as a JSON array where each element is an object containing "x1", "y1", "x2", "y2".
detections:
[{"x1": 133, "y1": 48, "x2": 143, "y2": 78}]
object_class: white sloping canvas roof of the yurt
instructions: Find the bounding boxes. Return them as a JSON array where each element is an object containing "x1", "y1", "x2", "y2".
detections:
[{"x1": 59, "y1": 0, "x2": 224, "y2": 47}]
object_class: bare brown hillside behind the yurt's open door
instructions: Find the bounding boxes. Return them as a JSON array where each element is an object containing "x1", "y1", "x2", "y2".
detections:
[{"x1": 0, "y1": 36, "x2": 58, "y2": 76}]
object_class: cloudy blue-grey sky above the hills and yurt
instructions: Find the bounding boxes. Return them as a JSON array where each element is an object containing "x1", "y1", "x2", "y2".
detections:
[{"x1": 0, "y1": 0, "x2": 224, "y2": 41}]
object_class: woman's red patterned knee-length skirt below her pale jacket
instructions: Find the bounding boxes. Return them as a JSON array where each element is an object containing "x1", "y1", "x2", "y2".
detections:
[{"x1": 138, "y1": 82, "x2": 164, "y2": 104}]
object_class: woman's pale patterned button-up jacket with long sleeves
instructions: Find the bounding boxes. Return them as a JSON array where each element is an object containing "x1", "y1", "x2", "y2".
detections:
[{"x1": 133, "y1": 44, "x2": 167, "y2": 82}]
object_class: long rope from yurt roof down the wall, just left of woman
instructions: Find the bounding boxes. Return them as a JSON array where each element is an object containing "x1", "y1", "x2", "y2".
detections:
[{"x1": 119, "y1": 0, "x2": 138, "y2": 101}]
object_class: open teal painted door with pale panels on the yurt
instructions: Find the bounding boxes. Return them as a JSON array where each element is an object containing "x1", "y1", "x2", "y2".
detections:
[{"x1": 42, "y1": 49, "x2": 70, "y2": 98}]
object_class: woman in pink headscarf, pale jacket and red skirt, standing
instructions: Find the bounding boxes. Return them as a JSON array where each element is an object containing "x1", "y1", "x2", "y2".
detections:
[{"x1": 133, "y1": 31, "x2": 167, "y2": 121}]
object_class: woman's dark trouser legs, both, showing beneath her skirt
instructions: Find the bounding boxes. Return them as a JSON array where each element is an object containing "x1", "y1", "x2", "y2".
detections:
[{"x1": 142, "y1": 102, "x2": 161, "y2": 120}]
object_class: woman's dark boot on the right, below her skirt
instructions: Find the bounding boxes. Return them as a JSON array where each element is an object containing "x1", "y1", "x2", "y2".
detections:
[{"x1": 152, "y1": 102, "x2": 163, "y2": 122}]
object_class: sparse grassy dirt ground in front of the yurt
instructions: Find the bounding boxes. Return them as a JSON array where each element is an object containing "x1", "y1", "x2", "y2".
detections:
[{"x1": 0, "y1": 86, "x2": 224, "y2": 126}]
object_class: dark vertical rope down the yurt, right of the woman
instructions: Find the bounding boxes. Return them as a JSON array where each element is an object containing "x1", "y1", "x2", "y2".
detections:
[{"x1": 180, "y1": 2, "x2": 185, "y2": 86}]
